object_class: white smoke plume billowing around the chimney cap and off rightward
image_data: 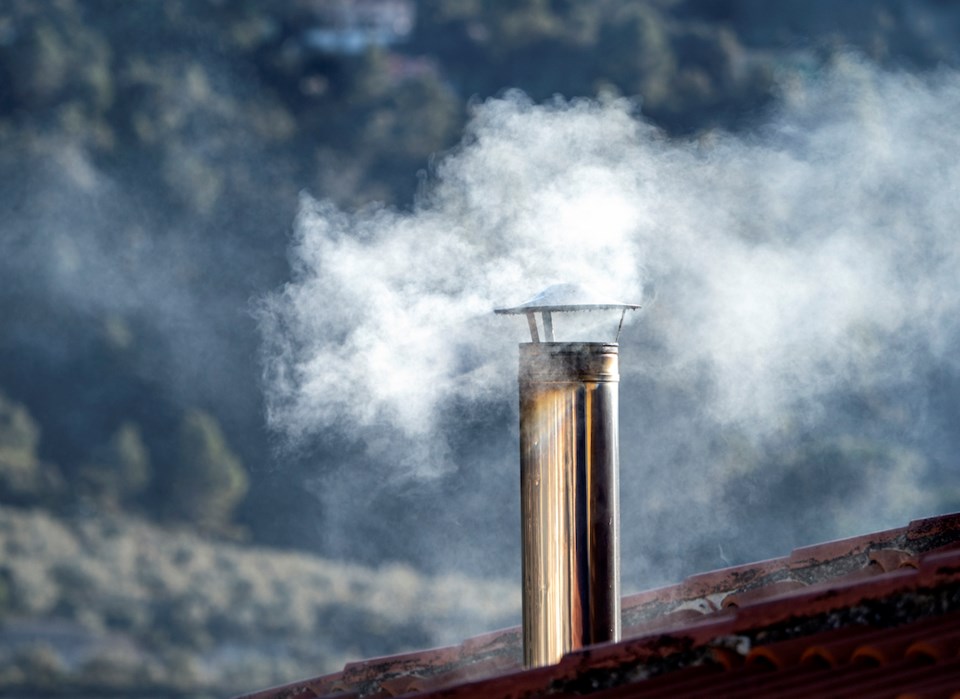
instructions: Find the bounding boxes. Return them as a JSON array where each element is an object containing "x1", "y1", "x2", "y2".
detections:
[{"x1": 259, "y1": 57, "x2": 960, "y2": 588}]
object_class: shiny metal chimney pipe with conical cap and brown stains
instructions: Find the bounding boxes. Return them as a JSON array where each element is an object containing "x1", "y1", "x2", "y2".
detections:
[{"x1": 496, "y1": 284, "x2": 638, "y2": 667}]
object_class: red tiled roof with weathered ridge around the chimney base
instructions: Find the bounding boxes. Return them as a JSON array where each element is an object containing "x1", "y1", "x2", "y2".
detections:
[{"x1": 236, "y1": 514, "x2": 960, "y2": 699}]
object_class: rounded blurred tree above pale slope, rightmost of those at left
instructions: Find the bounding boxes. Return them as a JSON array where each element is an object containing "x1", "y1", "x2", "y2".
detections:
[{"x1": 170, "y1": 410, "x2": 248, "y2": 530}]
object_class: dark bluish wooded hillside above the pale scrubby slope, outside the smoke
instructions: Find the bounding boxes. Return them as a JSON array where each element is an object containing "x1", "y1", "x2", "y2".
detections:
[{"x1": 7, "y1": 0, "x2": 960, "y2": 560}]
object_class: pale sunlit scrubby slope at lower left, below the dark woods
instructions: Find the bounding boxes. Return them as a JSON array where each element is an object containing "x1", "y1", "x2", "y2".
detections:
[{"x1": 0, "y1": 507, "x2": 519, "y2": 696}]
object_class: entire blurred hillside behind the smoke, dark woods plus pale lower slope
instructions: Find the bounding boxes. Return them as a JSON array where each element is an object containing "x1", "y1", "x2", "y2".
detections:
[{"x1": 0, "y1": 0, "x2": 960, "y2": 692}]
